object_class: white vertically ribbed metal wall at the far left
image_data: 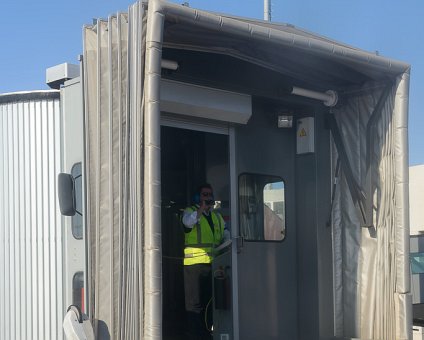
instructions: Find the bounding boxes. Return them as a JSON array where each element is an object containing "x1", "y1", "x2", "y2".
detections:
[{"x1": 0, "y1": 91, "x2": 63, "y2": 340}]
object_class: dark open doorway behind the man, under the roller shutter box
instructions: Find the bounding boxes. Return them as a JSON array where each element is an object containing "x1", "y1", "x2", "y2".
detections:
[{"x1": 161, "y1": 126, "x2": 230, "y2": 340}]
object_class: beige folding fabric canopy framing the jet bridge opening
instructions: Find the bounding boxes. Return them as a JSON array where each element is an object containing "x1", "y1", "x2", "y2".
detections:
[{"x1": 84, "y1": 0, "x2": 411, "y2": 339}]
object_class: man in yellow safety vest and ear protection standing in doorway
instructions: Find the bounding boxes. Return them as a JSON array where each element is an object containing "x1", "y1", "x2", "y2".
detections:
[{"x1": 182, "y1": 183, "x2": 230, "y2": 340}]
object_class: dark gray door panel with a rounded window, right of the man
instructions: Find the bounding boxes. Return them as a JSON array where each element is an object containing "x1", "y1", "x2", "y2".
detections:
[{"x1": 232, "y1": 108, "x2": 298, "y2": 340}]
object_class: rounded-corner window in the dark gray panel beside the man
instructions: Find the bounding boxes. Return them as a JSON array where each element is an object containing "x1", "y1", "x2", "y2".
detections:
[{"x1": 239, "y1": 174, "x2": 286, "y2": 241}]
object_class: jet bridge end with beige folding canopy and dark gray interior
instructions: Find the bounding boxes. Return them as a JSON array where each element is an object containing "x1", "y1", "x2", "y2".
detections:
[{"x1": 61, "y1": 0, "x2": 411, "y2": 339}]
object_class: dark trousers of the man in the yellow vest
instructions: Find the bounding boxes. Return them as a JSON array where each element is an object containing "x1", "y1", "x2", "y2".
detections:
[{"x1": 184, "y1": 264, "x2": 212, "y2": 340}]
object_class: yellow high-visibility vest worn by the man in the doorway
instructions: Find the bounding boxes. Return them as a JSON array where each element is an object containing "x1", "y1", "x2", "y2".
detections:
[{"x1": 184, "y1": 206, "x2": 225, "y2": 266}]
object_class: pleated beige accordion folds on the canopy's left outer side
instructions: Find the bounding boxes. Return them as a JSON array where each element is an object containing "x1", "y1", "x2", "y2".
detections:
[{"x1": 83, "y1": 3, "x2": 146, "y2": 339}]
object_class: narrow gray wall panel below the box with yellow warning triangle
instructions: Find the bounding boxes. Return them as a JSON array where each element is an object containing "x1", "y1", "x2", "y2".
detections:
[{"x1": 296, "y1": 110, "x2": 334, "y2": 339}]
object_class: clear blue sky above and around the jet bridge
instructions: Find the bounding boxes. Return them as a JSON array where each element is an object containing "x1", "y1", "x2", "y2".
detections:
[{"x1": 0, "y1": 0, "x2": 424, "y2": 165}]
